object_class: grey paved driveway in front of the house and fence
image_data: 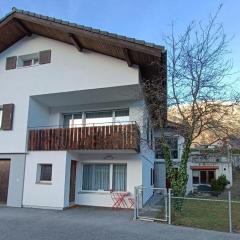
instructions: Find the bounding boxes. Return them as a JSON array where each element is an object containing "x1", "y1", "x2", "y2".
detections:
[{"x1": 0, "y1": 207, "x2": 240, "y2": 240}]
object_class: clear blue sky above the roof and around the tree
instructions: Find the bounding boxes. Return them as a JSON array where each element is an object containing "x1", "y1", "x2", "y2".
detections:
[{"x1": 0, "y1": 0, "x2": 240, "y2": 84}]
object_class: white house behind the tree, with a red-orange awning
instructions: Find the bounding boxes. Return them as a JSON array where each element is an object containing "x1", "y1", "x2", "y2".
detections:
[{"x1": 155, "y1": 131, "x2": 232, "y2": 193}]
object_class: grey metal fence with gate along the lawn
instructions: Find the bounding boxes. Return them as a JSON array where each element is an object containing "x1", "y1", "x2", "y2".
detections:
[{"x1": 135, "y1": 187, "x2": 240, "y2": 233}]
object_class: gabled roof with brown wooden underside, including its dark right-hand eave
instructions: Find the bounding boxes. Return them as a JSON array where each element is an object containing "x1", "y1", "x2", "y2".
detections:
[{"x1": 0, "y1": 8, "x2": 167, "y2": 124}]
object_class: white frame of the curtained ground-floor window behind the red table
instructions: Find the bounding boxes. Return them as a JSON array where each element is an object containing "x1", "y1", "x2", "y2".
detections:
[{"x1": 80, "y1": 162, "x2": 128, "y2": 194}]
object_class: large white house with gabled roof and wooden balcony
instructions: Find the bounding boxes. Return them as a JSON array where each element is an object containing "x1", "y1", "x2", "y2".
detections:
[{"x1": 0, "y1": 9, "x2": 166, "y2": 209}]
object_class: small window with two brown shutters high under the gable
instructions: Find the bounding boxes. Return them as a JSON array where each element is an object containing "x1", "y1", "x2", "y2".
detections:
[{"x1": 6, "y1": 50, "x2": 51, "y2": 70}]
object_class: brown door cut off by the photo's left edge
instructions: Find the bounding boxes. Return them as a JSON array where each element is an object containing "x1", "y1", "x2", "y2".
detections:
[{"x1": 0, "y1": 159, "x2": 10, "y2": 204}]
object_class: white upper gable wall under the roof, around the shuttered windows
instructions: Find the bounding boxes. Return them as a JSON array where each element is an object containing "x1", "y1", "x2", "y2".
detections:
[{"x1": 0, "y1": 36, "x2": 139, "y2": 153}]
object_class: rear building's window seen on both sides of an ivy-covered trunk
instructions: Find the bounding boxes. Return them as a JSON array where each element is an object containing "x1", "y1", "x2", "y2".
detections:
[{"x1": 155, "y1": 137, "x2": 178, "y2": 159}]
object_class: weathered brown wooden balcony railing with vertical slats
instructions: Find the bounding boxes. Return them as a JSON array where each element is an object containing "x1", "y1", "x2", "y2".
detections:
[{"x1": 28, "y1": 122, "x2": 140, "y2": 152}]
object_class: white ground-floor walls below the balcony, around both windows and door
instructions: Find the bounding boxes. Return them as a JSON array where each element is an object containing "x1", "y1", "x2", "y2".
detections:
[{"x1": 23, "y1": 151, "x2": 142, "y2": 209}]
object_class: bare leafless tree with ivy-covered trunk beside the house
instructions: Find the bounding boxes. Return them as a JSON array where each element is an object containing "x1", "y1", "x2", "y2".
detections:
[{"x1": 143, "y1": 6, "x2": 238, "y2": 209}]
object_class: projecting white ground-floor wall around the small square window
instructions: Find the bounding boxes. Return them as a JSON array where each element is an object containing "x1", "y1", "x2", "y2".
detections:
[{"x1": 23, "y1": 151, "x2": 69, "y2": 209}]
